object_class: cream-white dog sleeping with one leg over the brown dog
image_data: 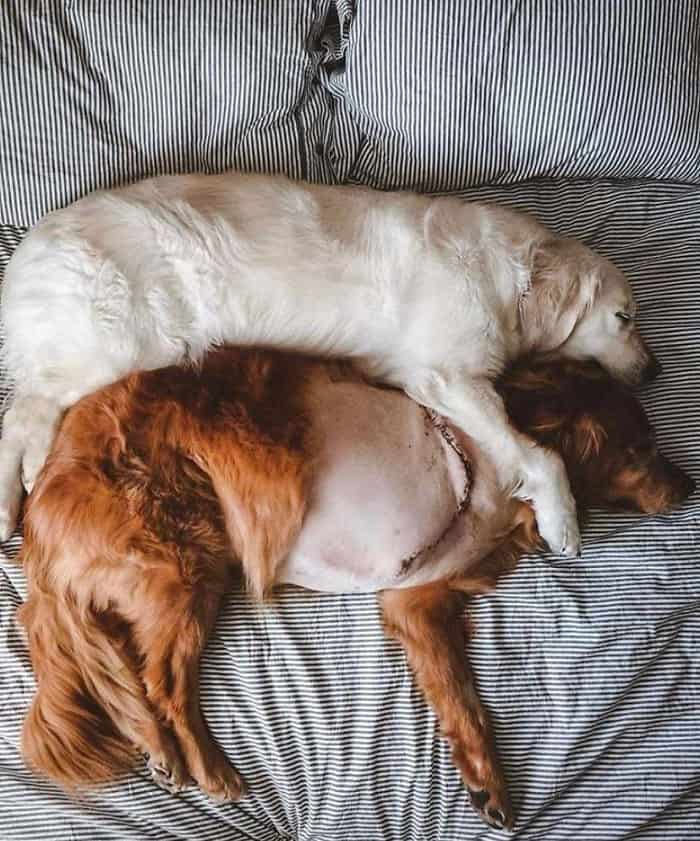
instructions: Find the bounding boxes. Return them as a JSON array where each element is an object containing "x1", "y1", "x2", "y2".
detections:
[{"x1": 0, "y1": 173, "x2": 657, "y2": 554}]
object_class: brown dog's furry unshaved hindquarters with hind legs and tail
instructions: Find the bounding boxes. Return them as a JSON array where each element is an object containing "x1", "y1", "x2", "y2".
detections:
[{"x1": 21, "y1": 352, "x2": 313, "y2": 797}]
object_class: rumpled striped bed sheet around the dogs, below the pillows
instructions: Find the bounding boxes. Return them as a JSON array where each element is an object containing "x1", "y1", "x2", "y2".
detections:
[{"x1": 0, "y1": 181, "x2": 700, "y2": 841}]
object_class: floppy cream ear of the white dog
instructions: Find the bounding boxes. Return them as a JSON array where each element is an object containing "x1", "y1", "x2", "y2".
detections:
[{"x1": 521, "y1": 237, "x2": 601, "y2": 352}]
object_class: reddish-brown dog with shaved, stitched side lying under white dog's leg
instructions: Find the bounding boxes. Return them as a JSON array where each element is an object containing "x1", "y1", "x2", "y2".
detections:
[{"x1": 21, "y1": 349, "x2": 692, "y2": 826}]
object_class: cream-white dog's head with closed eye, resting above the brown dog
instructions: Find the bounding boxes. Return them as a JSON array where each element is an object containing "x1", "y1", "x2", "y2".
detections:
[{"x1": 525, "y1": 237, "x2": 661, "y2": 385}]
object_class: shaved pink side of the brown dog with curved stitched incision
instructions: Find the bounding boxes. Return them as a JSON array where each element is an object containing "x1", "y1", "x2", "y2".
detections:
[{"x1": 278, "y1": 382, "x2": 498, "y2": 593}]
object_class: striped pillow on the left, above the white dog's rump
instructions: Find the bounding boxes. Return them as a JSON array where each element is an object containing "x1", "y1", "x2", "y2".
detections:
[{"x1": 0, "y1": 0, "x2": 325, "y2": 225}]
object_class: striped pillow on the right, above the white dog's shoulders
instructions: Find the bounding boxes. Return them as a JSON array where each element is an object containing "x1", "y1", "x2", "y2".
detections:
[{"x1": 334, "y1": 0, "x2": 700, "y2": 191}]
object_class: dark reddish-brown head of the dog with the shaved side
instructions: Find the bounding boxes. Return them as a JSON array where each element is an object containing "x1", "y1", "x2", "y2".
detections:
[{"x1": 499, "y1": 361, "x2": 695, "y2": 514}]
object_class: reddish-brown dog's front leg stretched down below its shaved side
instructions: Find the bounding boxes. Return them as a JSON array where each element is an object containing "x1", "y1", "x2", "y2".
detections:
[{"x1": 381, "y1": 580, "x2": 512, "y2": 828}]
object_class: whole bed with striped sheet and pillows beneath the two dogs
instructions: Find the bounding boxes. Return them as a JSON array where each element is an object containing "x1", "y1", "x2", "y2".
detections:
[{"x1": 0, "y1": 0, "x2": 700, "y2": 841}]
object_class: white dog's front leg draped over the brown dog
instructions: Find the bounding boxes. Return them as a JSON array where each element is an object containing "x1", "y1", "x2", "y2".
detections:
[{"x1": 406, "y1": 372, "x2": 581, "y2": 555}]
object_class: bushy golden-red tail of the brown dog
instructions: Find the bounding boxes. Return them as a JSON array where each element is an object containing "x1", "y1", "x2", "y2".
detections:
[{"x1": 20, "y1": 576, "x2": 148, "y2": 789}]
